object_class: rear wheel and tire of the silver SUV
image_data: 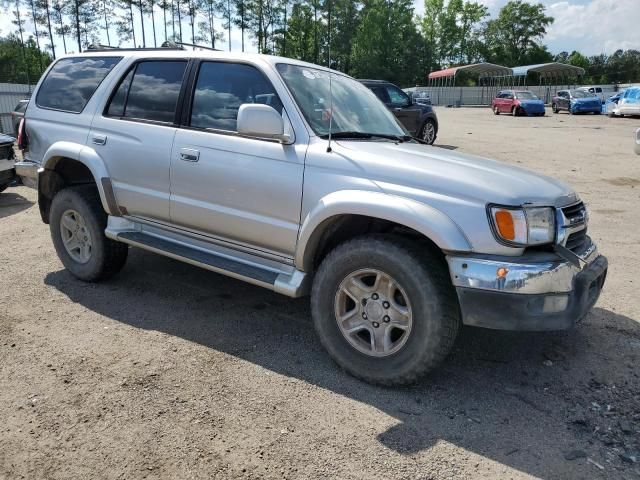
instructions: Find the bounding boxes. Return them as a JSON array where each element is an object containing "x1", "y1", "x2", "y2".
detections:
[{"x1": 49, "y1": 185, "x2": 129, "y2": 282}]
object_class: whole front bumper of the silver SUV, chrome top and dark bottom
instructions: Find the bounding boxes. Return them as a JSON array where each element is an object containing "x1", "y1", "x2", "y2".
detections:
[{"x1": 447, "y1": 244, "x2": 608, "y2": 331}]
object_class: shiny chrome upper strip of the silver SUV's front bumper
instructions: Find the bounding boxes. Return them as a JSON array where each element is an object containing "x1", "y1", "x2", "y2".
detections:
[{"x1": 447, "y1": 244, "x2": 599, "y2": 295}]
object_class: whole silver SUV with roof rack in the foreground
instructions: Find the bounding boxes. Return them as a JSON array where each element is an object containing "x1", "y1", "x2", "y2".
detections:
[{"x1": 17, "y1": 49, "x2": 607, "y2": 385}]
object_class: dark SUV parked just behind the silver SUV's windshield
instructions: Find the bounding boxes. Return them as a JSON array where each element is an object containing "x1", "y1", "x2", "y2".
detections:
[{"x1": 360, "y1": 80, "x2": 438, "y2": 145}]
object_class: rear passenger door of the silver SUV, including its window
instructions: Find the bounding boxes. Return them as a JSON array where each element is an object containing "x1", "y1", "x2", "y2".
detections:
[{"x1": 88, "y1": 59, "x2": 188, "y2": 222}]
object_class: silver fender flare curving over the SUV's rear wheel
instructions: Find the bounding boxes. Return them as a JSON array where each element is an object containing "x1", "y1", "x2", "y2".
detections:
[{"x1": 39, "y1": 142, "x2": 120, "y2": 215}]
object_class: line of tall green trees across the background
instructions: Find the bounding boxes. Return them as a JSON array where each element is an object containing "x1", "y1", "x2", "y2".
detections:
[{"x1": 0, "y1": 0, "x2": 640, "y2": 86}]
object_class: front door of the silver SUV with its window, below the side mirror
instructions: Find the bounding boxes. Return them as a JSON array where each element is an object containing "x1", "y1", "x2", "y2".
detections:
[{"x1": 171, "y1": 61, "x2": 306, "y2": 258}]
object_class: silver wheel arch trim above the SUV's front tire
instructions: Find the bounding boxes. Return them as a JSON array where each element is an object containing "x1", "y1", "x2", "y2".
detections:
[{"x1": 294, "y1": 190, "x2": 471, "y2": 272}]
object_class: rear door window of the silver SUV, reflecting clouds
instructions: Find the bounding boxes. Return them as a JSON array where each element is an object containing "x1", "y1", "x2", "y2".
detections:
[{"x1": 123, "y1": 60, "x2": 187, "y2": 123}]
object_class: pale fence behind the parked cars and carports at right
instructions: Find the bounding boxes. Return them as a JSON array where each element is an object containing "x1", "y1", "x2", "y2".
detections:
[{"x1": 411, "y1": 85, "x2": 614, "y2": 106}]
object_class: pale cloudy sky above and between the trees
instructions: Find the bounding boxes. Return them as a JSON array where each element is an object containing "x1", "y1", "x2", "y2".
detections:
[{"x1": 0, "y1": 0, "x2": 640, "y2": 59}]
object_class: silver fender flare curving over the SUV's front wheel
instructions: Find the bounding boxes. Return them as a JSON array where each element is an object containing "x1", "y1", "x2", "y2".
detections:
[{"x1": 294, "y1": 190, "x2": 472, "y2": 271}]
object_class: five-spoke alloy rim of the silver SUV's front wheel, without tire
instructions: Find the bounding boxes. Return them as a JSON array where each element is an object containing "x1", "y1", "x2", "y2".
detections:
[{"x1": 334, "y1": 268, "x2": 413, "y2": 357}]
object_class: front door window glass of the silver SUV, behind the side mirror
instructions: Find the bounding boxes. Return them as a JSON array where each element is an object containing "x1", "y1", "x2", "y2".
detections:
[{"x1": 190, "y1": 62, "x2": 283, "y2": 132}]
